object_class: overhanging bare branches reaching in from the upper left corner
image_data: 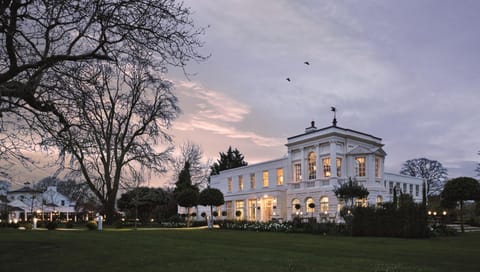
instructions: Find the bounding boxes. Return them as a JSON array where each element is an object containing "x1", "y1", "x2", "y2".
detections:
[{"x1": 0, "y1": 0, "x2": 203, "y2": 118}]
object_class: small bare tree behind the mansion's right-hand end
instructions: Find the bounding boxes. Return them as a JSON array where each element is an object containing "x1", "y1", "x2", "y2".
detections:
[{"x1": 400, "y1": 158, "x2": 448, "y2": 196}]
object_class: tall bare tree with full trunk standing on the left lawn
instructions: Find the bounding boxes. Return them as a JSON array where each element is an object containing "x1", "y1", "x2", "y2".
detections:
[{"x1": 31, "y1": 64, "x2": 179, "y2": 220}]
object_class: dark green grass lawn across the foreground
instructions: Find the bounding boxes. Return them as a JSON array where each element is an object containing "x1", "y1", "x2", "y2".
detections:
[{"x1": 0, "y1": 229, "x2": 480, "y2": 272}]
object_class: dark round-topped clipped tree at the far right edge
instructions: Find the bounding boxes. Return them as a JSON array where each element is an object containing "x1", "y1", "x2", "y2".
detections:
[{"x1": 441, "y1": 177, "x2": 480, "y2": 232}]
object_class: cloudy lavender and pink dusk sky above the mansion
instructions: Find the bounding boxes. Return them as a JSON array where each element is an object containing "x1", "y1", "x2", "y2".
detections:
[{"x1": 4, "y1": 0, "x2": 480, "y2": 186}]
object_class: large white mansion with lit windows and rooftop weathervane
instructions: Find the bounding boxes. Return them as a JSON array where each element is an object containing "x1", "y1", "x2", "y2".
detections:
[{"x1": 210, "y1": 120, "x2": 423, "y2": 221}]
